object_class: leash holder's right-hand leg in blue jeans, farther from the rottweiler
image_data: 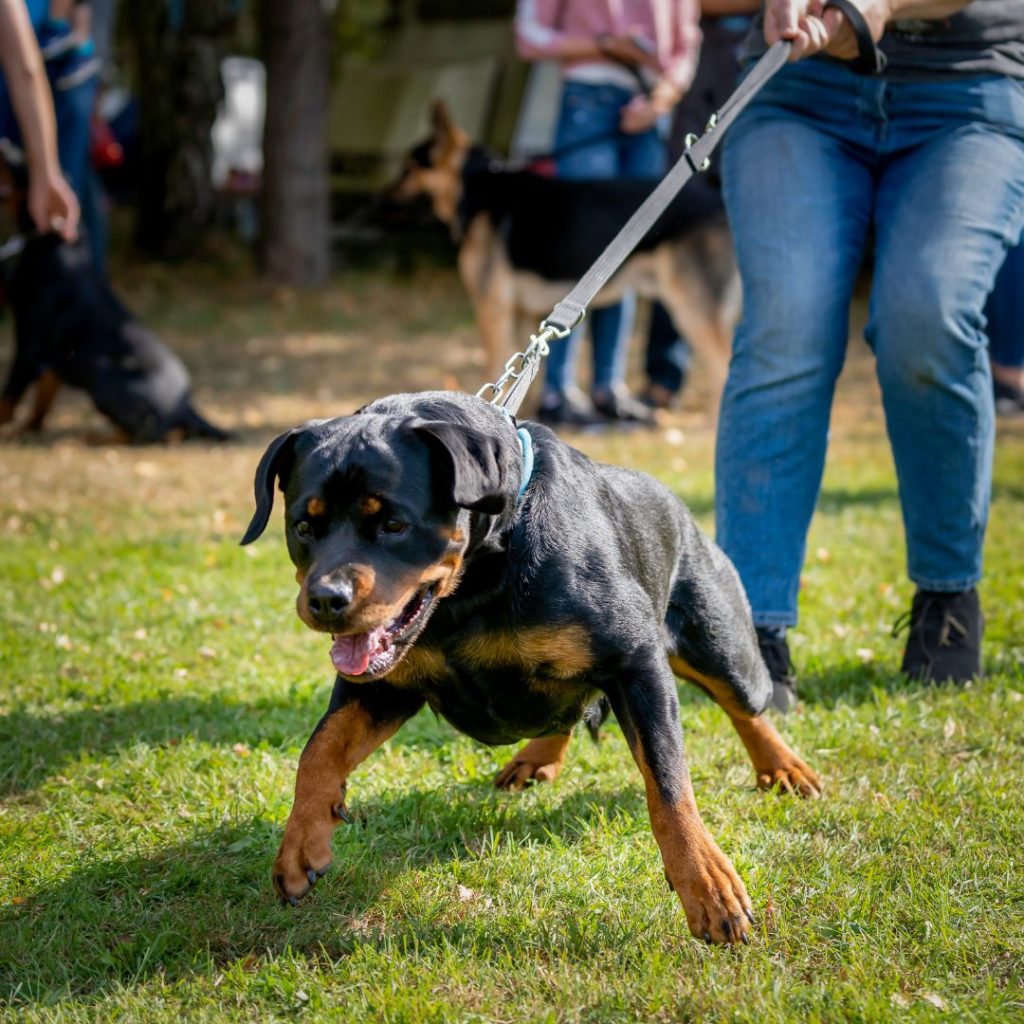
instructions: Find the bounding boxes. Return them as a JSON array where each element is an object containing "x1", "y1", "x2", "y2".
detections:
[{"x1": 866, "y1": 79, "x2": 1024, "y2": 679}]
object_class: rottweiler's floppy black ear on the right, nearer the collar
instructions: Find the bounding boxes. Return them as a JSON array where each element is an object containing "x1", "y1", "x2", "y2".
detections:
[{"x1": 413, "y1": 421, "x2": 508, "y2": 515}]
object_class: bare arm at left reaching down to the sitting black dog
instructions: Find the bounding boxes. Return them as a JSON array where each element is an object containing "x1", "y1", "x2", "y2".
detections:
[{"x1": 0, "y1": 0, "x2": 79, "y2": 241}]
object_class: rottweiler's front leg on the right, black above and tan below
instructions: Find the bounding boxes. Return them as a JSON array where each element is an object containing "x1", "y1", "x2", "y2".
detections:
[{"x1": 607, "y1": 654, "x2": 754, "y2": 944}]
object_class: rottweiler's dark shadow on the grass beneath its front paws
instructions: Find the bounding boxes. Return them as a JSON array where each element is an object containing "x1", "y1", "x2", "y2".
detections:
[{"x1": 0, "y1": 783, "x2": 644, "y2": 1006}]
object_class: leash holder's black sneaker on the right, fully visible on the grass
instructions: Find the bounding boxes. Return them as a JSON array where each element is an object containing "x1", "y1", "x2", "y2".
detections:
[{"x1": 893, "y1": 587, "x2": 985, "y2": 683}]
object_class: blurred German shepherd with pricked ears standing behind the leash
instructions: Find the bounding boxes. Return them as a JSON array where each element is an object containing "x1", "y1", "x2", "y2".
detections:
[{"x1": 389, "y1": 100, "x2": 740, "y2": 416}]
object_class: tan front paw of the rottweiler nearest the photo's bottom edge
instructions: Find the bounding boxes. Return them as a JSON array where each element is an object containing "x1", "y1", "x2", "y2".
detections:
[{"x1": 666, "y1": 837, "x2": 754, "y2": 945}]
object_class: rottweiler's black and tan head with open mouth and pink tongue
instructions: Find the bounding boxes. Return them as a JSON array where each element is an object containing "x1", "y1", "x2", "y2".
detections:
[{"x1": 242, "y1": 392, "x2": 521, "y2": 682}]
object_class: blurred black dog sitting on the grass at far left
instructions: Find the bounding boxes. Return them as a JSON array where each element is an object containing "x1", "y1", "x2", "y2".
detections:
[{"x1": 0, "y1": 234, "x2": 228, "y2": 443}]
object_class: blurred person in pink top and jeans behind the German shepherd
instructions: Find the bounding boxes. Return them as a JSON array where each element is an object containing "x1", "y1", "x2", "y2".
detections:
[{"x1": 515, "y1": 0, "x2": 700, "y2": 426}]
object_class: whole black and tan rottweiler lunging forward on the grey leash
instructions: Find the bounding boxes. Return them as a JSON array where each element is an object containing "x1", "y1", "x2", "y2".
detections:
[{"x1": 242, "y1": 392, "x2": 820, "y2": 943}]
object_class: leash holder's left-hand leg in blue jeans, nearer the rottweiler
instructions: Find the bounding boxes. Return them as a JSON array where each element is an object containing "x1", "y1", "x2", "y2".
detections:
[{"x1": 715, "y1": 59, "x2": 873, "y2": 627}]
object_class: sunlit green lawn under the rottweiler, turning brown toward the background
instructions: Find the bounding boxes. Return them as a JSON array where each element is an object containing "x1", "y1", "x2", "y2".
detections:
[{"x1": 0, "y1": 269, "x2": 1024, "y2": 1022}]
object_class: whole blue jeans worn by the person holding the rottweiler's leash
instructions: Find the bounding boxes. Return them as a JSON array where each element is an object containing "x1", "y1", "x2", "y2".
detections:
[{"x1": 716, "y1": 59, "x2": 1024, "y2": 626}]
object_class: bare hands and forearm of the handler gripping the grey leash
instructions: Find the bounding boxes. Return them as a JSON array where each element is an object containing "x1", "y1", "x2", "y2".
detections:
[{"x1": 765, "y1": 0, "x2": 971, "y2": 60}]
